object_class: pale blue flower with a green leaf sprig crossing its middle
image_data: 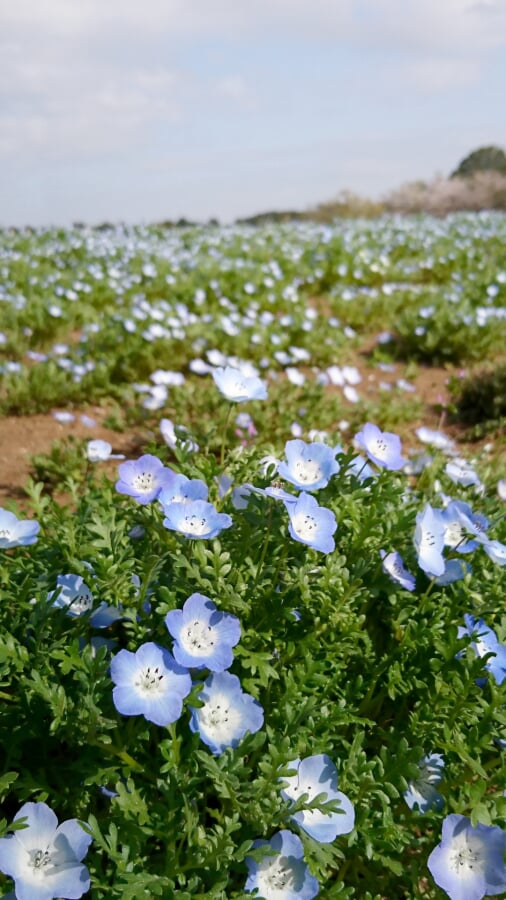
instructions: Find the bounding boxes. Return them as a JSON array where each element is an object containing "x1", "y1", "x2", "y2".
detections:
[{"x1": 281, "y1": 753, "x2": 355, "y2": 844}]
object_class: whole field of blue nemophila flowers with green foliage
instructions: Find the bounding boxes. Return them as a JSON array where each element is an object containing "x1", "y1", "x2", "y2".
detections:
[{"x1": 0, "y1": 214, "x2": 506, "y2": 900}]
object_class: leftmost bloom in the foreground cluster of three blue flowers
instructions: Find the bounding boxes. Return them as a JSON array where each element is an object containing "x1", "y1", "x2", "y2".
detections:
[{"x1": 111, "y1": 642, "x2": 192, "y2": 725}]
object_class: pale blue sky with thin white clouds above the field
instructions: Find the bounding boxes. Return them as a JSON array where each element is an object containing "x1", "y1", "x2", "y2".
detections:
[{"x1": 0, "y1": 0, "x2": 506, "y2": 226}]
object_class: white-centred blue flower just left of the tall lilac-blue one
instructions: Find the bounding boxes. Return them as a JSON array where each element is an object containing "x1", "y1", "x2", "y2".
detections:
[{"x1": 278, "y1": 439, "x2": 339, "y2": 491}]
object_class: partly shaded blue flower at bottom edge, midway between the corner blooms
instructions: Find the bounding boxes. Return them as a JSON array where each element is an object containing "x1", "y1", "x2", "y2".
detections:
[{"x1": 244, "y1": 830, "x2": 319, "y2": 900}]
